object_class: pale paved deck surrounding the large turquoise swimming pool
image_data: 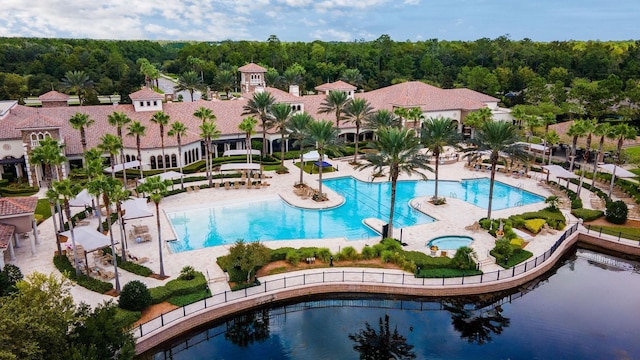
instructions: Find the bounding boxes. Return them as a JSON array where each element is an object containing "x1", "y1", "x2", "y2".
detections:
[{"x1": 5, "y1": 158, "x2": 590, "y2": 306}]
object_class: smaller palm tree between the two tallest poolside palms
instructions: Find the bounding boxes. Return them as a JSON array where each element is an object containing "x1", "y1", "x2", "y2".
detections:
[{"x1": 420, "y1": 117, "x2": 462, "y2": 201}]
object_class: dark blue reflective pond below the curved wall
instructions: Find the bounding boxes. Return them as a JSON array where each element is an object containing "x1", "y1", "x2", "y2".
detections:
[{"x1": 144, "y1": 249, "x2": 640, "y2": 360}]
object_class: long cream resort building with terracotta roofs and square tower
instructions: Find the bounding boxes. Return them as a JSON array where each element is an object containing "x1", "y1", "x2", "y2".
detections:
[{"x1": 0, "y1": 64, "x2": 512, "y2": 186}]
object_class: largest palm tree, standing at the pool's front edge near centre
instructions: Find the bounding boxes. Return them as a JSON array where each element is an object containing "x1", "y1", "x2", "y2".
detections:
[{"x1": 356, "y1": 127, "x2": 432, "y2": 238}]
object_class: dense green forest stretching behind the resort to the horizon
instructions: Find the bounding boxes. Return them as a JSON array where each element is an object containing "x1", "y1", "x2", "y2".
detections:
[{"x1": 0, "y1": 35, "x2": 640, "y2": 118}]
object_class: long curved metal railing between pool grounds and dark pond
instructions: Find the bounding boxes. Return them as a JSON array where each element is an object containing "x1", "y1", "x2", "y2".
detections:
[{"x1": 132, "y1": 223, "x2": 578, "y2": 338}]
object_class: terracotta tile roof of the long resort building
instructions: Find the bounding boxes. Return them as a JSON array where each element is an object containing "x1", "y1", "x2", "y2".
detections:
[{"x1": 0, "y1": 81, "x2": 504, "y2": 155}]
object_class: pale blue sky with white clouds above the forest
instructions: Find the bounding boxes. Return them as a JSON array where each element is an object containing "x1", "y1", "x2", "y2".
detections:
[{"x1": 0, "y1": 0, "x2": 640, "y2": 42}]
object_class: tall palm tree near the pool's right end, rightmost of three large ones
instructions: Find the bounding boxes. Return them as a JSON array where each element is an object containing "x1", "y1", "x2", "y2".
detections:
[{"x1": 464, "y1": 121, "x2": 528, "y2": 219}]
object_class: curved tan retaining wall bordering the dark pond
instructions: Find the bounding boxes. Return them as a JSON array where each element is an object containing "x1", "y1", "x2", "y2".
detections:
[{"x1": 134, "y1": 225, "x2": 640, "y2": 354}]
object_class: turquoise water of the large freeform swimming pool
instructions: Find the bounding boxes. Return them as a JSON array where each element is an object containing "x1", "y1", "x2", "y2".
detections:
[{"x1": 167, "y1": 177, "x2": 544, "y2": 252}]
